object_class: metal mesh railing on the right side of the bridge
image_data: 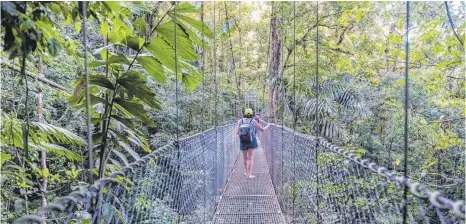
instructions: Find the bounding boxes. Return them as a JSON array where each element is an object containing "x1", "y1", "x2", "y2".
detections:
[{"x1": 262, "y1": 126, "x2": 465, "y2": 223}]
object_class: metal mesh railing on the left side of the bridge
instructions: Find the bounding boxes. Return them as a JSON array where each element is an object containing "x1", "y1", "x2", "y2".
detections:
[{"x1": 15, "y1": 124, "x2": 239, "y2": 223}]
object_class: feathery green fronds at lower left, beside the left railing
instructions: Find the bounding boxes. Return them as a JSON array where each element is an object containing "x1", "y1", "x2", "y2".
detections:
[{"x1": 0, "y1": 113, "x2": 86, "y2": 218}]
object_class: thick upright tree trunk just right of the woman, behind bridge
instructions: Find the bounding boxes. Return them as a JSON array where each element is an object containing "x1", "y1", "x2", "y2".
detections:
[{"x1": 268, "y1": 3, "x2": 282, "y2": 123}]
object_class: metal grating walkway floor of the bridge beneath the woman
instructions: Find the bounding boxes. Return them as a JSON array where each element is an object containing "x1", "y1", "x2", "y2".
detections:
[{"x1": 213, "y1": 144, "x2": 285, "y2": 224}]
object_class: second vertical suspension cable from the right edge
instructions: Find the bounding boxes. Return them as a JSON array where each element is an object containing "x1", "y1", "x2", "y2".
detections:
[{"x1": 315, "y1": 1, "x2": 320, "y2": 220}]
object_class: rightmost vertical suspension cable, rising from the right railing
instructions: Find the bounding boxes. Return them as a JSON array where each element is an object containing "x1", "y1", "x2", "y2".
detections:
[{"x1": 403, "y1": 1, "x2": 409, "y2": 223}]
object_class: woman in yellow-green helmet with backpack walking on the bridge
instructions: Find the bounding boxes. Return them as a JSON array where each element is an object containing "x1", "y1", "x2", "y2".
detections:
[{"x1": 236, "y1": 108, "x2": 270, "y2": 178}]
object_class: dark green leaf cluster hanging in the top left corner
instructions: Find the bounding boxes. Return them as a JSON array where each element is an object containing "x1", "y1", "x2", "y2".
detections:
[{"x1": 2, "y1": 2, "x2": 79, "y2": 59}]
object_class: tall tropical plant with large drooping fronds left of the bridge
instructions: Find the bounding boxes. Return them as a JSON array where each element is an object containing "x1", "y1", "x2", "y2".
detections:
[{"x1": 69, "y1": 2, "x2": 210, "y2": 177}]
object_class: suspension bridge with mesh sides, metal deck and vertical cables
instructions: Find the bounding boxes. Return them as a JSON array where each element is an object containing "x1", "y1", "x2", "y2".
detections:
[{"x1": 9, "y1": 0, "x2": 465, "y2": 224}]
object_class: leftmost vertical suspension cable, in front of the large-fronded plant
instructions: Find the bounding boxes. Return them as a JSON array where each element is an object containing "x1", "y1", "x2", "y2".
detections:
[{"x1": 81, "y1": 1, "x2": 94, "y2": 184}]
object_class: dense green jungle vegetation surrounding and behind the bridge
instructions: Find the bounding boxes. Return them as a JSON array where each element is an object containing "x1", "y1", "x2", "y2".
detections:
[{"x1": 0, "y1": 1, "x2": 466, "y2": 222}]
